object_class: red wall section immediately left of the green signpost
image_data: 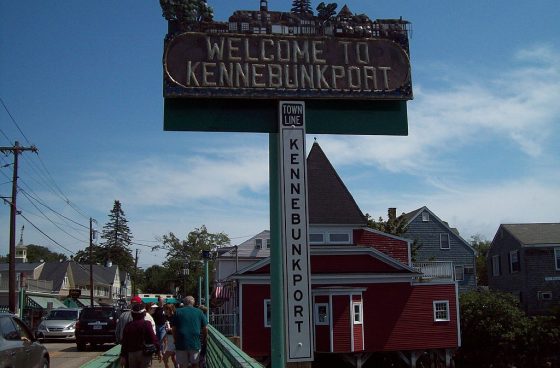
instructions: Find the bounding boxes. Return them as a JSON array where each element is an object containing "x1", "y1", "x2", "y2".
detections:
[{"x1": 241, "y1": 285, "x2": 271, "y2": 356}]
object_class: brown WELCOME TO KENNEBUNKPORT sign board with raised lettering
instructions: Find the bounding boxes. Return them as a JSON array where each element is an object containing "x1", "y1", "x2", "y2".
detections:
[{"x1": 164, "y1": 32, "x2": 412, "y2": 100}]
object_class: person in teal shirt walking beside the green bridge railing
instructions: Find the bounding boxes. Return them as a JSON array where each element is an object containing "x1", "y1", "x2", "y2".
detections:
[{"x1": 171, "y1": 296, "x2": 208, "y2": 368}]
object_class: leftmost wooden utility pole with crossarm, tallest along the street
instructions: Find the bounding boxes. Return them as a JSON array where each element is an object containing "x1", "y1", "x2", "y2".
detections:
[{"x1": 0, "y1": 141, "x2": 37, "y2": 314}]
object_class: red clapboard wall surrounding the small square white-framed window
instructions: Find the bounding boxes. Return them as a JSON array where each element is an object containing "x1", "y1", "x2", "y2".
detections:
[{"x1": 364, "y1": 283, "x2": 457, "y2": 351}]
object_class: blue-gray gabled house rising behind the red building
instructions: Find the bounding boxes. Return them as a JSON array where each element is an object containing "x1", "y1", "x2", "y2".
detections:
[{"x1": 403, "y1": 206, "x2": 476, "y2": 292}]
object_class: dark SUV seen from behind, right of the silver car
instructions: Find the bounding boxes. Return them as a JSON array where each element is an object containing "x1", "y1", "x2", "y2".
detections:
[{"x1": 76, "y1": 306, "x2": 118, "y2": 351}]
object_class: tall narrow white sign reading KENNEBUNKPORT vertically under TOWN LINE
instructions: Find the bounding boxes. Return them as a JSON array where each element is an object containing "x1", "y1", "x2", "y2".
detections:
[{"x1": 279, "y1": 101, "x2": 313, "y2": 362}]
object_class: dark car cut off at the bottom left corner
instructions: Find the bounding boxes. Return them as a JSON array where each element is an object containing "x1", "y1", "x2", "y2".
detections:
[{"x1": 0, "y1": 313, "x2": 50, "y2": 368}]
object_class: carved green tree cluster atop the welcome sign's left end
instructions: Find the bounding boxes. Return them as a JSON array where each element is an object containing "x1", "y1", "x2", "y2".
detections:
[{"x1": 163, "y1": 0, "x2": 214, "y2": 23}]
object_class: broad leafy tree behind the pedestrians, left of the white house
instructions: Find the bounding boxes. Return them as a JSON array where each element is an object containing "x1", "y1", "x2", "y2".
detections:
[{"x1": 156, "y1": 225, "x2": 230, "y2": 295}]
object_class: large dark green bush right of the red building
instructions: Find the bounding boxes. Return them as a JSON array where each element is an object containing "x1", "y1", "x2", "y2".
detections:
[{"x1": 457, "y1": 291, "x2": 560, "y2": 367}]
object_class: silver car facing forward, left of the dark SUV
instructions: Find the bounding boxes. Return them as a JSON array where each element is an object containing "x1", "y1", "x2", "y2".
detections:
[{"x1": 37, "y1": 308, "x2": 80, "y2": 340}]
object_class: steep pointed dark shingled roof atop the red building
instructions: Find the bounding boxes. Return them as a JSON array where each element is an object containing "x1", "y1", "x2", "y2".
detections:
[{"x1": 307, "y1": 142, "x2": 367, "y2": 226}]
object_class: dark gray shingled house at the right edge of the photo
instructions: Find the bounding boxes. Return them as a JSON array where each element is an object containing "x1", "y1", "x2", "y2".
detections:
[{"x1": 488, "y1": 223, "x2": 560, "y2": 315}]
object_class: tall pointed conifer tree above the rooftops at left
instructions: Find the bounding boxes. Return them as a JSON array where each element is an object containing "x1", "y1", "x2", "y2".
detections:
[{"x1": 97, "y1": 200, "x2": 134, "y2": 272}]
